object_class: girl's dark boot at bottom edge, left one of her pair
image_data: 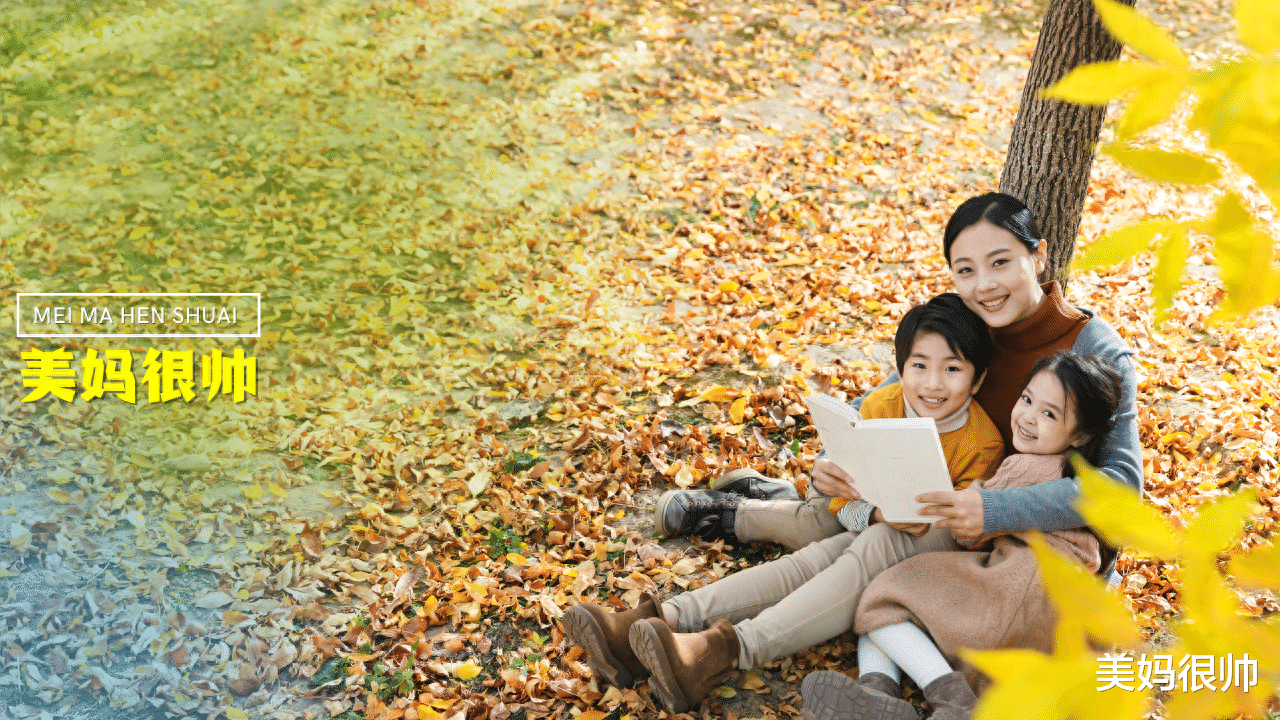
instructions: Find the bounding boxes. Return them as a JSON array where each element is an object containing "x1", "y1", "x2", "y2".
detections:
[{"x1": 800, "y1": 670, "x2": 916, "y2": 720}]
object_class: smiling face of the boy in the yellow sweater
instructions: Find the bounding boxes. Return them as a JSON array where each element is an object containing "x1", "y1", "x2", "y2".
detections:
[{"x1": 901, "y1": 333, "x2": 982, "y2": 420}]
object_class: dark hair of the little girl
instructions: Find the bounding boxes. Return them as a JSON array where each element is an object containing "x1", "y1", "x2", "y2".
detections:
[{"x1": 1023, "y1": 350, "x2": 1123, "y2": 470}]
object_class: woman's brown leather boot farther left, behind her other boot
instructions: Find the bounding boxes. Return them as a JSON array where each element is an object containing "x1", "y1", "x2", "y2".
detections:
[{"x1": 561, "y1": 593, "x2": 662, "y2": 687}]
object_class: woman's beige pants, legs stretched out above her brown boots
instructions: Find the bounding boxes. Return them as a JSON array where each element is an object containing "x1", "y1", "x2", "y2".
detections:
[{"x1": 664, "y1": 524, "x2": 961, "y2": 670}]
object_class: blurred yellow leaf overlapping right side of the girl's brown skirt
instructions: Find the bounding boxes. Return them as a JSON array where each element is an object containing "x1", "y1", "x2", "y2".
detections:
[{"x1": 1028, "y1": 533, "x2": 1142, "y2": 646}]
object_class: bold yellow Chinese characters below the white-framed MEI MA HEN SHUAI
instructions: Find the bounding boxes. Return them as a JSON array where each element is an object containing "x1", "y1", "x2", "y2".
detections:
[{"x1": 22, "y1": 347, "x2": 257, "y2": 402}]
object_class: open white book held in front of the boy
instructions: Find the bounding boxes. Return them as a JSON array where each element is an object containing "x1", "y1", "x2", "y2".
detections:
[{"x1": 805, "y1": 393, "x2": 954, "y2": 523}]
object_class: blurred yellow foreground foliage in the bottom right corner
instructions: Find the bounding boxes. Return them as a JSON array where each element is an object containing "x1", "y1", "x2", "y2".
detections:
[{"x1": 964, "y1": 459, "x2": 1280, "y2": 720}]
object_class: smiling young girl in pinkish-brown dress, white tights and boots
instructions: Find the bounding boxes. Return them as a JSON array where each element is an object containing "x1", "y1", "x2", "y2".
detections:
[{"x1": 803, "y1": 351, "x2": 1121, "y2": 720}]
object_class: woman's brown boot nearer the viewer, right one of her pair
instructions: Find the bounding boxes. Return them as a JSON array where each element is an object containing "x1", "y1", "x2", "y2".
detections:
[{"x1": 631, "y1": 619, "x2": 739, "y2": 712}]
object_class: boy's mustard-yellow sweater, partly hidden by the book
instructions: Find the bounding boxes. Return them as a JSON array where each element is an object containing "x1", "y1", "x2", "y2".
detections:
[{"x1": 831, "y1": 383, "x2": 1005, "y2": 512}]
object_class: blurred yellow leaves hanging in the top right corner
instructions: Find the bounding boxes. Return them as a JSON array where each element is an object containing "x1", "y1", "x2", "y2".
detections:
[{"x1": 1042, "y1": 0, "x2": 1280, "y2": 323}]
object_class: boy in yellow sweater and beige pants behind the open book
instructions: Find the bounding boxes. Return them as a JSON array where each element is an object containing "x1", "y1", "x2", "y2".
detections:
[{"x1": 655, "y1": 293, "x2": 1005, "y2": 550}]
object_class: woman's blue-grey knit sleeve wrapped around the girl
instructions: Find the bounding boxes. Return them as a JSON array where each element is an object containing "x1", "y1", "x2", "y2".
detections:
[{"x1": 978, "y1": 318, "x2": 1142, "y2": 534}]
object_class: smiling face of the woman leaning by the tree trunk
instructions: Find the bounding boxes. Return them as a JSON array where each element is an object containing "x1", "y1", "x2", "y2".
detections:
[{"x1": 951, "y1": 220, "x2": 1046, "y2": 328}]
